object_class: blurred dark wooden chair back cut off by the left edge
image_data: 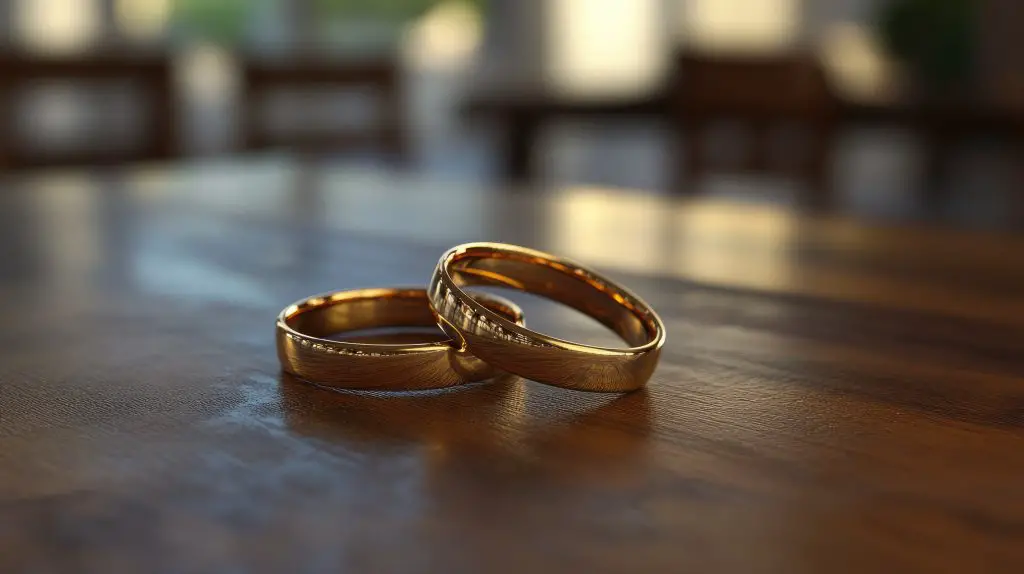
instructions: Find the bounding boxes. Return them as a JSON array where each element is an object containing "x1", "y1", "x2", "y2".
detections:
[{"x1": 0, "y1": 52, "x2": 177, "y2": 169}]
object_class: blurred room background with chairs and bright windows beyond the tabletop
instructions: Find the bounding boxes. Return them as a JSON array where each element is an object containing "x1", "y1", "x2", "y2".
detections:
[{"x1": 0, "y1": 0, "x2": 1024, "y2": 228}]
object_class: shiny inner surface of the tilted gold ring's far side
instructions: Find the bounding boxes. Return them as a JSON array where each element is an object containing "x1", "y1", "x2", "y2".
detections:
[{"x1": 449, "y1": 249, "x2": 658, "y2": 347}]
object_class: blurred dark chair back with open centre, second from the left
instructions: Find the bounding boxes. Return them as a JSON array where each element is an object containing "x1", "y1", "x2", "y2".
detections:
[{"x1": 242, "y1": 56, "x2": 409, "y2": 161}]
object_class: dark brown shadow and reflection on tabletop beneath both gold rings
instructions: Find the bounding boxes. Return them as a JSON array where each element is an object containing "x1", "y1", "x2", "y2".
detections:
[{"x1": 279, "y1": 335, "x2": 653, "y2": 482}]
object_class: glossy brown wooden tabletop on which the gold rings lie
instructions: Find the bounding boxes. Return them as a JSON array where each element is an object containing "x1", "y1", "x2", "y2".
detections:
[{"x1": 0, "y1": 161, "x2": 1024, "y2": 573}]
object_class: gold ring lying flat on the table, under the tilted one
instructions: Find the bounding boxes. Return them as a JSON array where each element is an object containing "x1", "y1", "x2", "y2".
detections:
[{"x1": 275, "y1": 289, "x2": 522, "y2": 390}]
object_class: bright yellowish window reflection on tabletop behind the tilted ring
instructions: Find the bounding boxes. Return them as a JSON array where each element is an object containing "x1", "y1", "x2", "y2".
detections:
[{"x1": 547, "y1": 187, "x2": 798, "y2": 290}]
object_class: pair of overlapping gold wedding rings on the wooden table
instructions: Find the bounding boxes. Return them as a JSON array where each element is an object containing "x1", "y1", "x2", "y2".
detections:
[{"x1": 276, "y1": 242, "x2": 665, "y2": 392}]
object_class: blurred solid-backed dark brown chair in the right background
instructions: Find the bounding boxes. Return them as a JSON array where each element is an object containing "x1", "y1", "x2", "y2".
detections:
[{"x1": 670, "y1": 53, "x2": 838, "y2": 202}]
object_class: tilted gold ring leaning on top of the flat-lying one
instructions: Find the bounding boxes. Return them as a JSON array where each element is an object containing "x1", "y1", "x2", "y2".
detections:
[{"x1": 428, "y1": 242, "x2": 665, "y2": 392}]
